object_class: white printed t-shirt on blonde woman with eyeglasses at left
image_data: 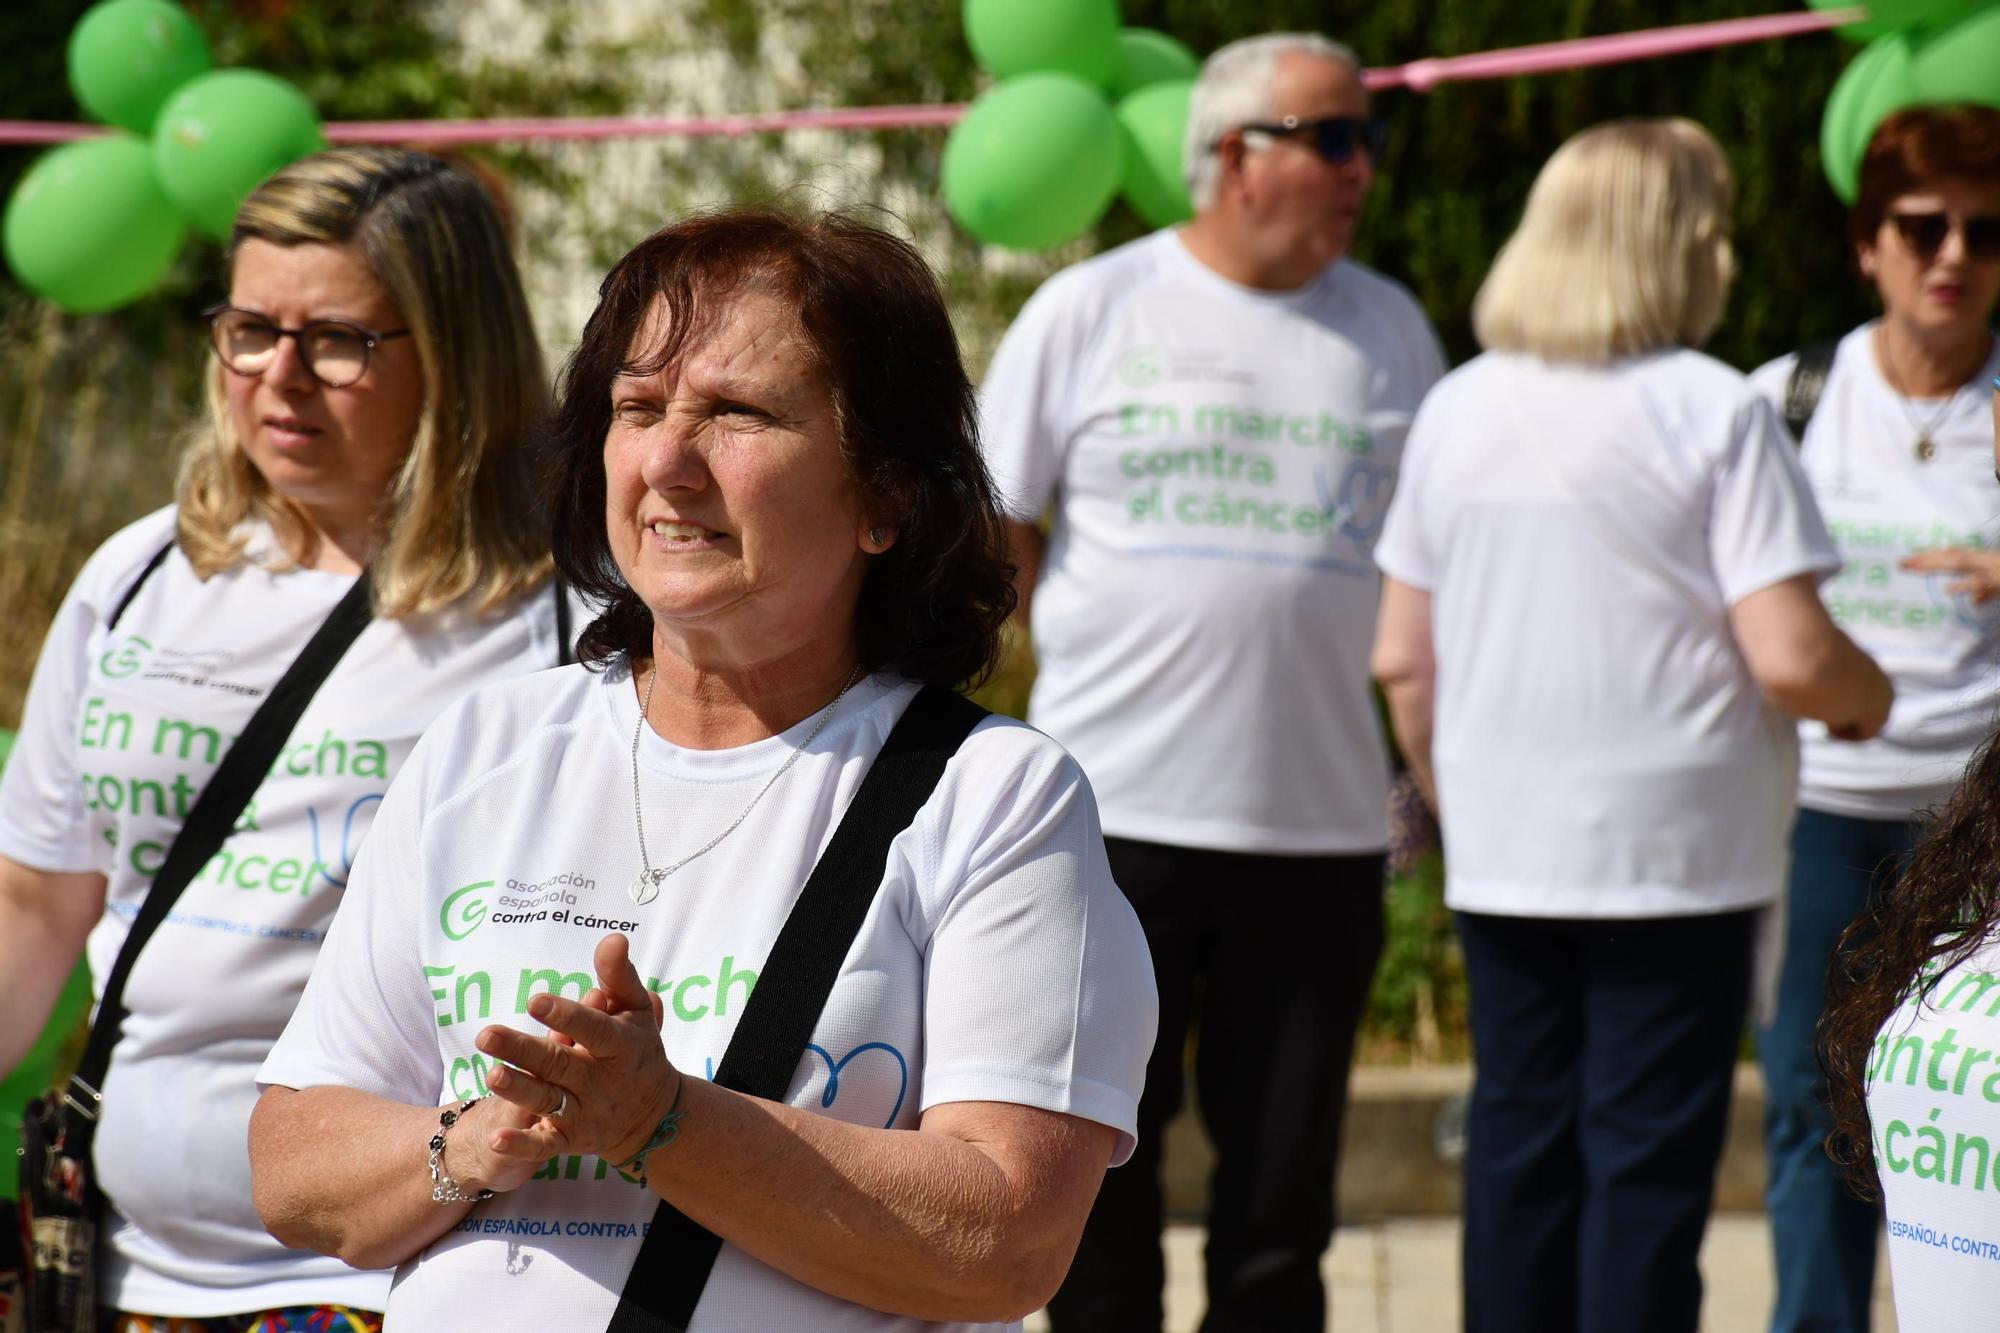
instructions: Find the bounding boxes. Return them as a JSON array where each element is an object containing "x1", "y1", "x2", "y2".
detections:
[{"x1": 0, "y1": 508, "x2": 558, "y2": 1317}]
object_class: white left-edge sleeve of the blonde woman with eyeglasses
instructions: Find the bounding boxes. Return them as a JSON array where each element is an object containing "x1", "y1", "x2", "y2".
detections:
[{"x1": 0, "y1": 508, "x2": 174, "y2": 873}]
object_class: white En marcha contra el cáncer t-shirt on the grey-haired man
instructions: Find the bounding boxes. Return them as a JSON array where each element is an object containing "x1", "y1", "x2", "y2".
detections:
[{"x1": 980, "y1": 232, "x2": 1444, "y2": 855}]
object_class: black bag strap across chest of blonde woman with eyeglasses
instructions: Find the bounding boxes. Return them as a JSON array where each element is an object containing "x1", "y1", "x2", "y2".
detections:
[{"x1": 64, "y1": 560, "x2": 376, "y2": 1120}]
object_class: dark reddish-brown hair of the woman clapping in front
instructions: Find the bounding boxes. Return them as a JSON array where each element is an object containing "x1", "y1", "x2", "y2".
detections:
[{"x1": 550, "y1": 210, "x2": 1014, "y2": 685}]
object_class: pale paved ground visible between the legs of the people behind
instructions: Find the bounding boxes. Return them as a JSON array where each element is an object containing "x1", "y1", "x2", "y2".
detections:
[{"x1": 1028, "y1": 1213, "x2": 1896, "y2": 1333}]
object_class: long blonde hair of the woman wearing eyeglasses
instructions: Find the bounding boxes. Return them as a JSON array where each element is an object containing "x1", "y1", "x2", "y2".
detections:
[{"x1": 176, "y1": 148, "x2": 552, "y2": 618}]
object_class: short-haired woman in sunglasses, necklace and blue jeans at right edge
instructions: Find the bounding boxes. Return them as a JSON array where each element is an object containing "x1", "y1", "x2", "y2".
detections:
[{"x1": 1754, "y1": 108, "x2": 2000, "y2": 1333}]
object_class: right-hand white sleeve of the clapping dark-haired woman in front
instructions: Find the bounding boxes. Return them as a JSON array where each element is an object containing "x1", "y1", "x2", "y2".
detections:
[{"x1": 918, "y1": 723, "x2": 1158, "y2": 1165}]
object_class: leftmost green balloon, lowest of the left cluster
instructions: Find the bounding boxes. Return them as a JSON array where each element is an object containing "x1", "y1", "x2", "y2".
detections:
[{"x1": 0, "y1": 132, "x2": 188, "y2": 314}]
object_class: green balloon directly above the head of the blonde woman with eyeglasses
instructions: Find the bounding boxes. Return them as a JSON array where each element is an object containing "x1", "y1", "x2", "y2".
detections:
[{"x1": 152, "y1": 70, "x2": 326, "y2": 240}]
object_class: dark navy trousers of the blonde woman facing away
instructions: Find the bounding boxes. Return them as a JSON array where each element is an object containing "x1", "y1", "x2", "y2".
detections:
[{"x1": 1458, "y1": 911, "x2": 1756, "y2": 1333}]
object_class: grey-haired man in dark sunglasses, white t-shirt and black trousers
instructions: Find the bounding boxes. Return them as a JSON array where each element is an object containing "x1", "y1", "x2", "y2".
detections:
[{"x1": 982, "y1": 34, "x2": 1444, "y2": 1333}]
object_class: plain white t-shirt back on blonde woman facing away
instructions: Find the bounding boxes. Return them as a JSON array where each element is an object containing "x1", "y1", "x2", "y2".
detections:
[{"x1": 1376, "y1": 350, "x2": 1840, "y2": 917}]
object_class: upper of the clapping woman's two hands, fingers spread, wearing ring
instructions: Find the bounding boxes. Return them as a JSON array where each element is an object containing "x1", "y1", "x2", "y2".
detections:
[{"x1": 474, "y1": 935, "x2": 682, "y2": 1163}]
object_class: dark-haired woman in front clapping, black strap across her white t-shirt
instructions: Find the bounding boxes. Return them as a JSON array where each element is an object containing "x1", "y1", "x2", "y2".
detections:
[{"x1": 250, "y1": 212, "x2": 1154, "y2": 1331}]
